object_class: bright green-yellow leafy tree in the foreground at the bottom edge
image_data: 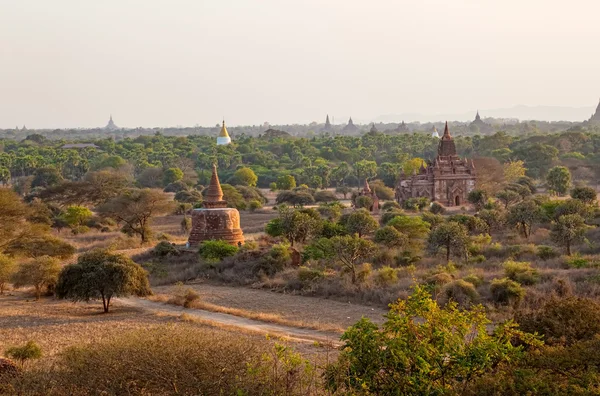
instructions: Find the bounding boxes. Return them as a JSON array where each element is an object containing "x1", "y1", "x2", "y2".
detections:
[{"x1": 326, "y1": 286, "x2": 541, "y2": 396}]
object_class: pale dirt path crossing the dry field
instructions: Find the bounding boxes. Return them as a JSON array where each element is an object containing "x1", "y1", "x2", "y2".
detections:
[{"x1": 117, "y1": 298, "x2": 340, "y2": 344}]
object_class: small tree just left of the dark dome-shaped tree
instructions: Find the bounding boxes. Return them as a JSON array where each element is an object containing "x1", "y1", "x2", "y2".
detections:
[{"x1": 13, "y1": 256, "x2": 60, "y2": 300}]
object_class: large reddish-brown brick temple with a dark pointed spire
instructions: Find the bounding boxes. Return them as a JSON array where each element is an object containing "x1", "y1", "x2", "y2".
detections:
[{"x1": 396, "y1": 122, "x2": 476, "y2": 206}]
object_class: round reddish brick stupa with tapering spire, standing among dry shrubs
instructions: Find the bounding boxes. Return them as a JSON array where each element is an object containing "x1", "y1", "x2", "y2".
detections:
[{"x1": 188, "y1": 165, "x2": 244, "y2": 246}]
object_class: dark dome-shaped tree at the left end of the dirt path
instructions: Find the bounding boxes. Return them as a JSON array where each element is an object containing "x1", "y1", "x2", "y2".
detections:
[{"x1": 56, "y1": 249, "x2": 152, "y2": 313}]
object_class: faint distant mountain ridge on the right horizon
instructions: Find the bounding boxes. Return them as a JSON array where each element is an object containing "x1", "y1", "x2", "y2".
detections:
[{"x1": 370, "y1": 105, "x2": 595, "y2": 123}]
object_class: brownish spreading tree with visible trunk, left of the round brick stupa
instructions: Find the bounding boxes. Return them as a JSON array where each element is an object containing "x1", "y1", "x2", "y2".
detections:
[{"x1": 98, "y1": 189, "x2": 173, "y2": 244}]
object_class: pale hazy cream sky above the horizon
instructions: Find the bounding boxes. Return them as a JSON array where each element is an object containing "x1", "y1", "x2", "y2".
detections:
[{"x1": 0, "y1": 0, "x2": 600, "y2": 128}]
